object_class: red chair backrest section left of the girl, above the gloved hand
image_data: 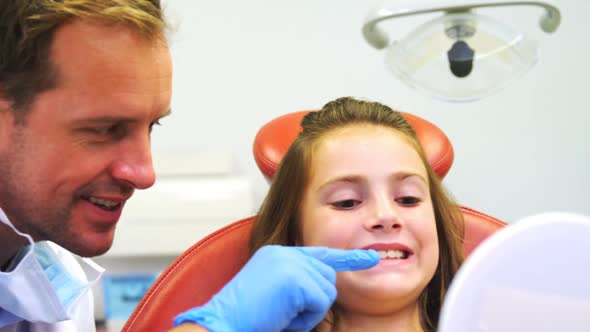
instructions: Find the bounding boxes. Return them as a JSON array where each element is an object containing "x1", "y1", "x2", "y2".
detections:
[{"x1": 122, "y1": 217, "x2": 254, "y2": 332}]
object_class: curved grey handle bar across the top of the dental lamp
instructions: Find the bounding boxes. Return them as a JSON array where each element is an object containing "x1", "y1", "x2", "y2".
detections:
[{"x1": 363, "y1": 0, "x2": 561, "y2": 49}]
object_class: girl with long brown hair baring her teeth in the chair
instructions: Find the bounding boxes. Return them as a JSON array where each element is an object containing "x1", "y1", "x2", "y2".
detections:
[{"x1": 250, "y1": 98, "x2": 463, "y2": 332}]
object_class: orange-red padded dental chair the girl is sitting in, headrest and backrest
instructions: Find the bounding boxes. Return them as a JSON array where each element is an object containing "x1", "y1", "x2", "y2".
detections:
[{"x1": 123, "y1": 111, "x2": 506, "y2": 332}]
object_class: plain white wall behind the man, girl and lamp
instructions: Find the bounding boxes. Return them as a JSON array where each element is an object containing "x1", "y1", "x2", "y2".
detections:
[{"x1": 153, "y1": 0, "x2": 590, "y2": 222}]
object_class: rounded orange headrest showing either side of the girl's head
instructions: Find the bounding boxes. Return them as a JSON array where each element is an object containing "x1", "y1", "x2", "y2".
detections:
[{"x1": 254, "y1": 111, "x2": 454, "y2": 179}]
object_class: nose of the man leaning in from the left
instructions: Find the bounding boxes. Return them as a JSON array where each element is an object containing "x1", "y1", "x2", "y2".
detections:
[{"x1": 111, "y1": 137, "x2": 156, "y2": 189}]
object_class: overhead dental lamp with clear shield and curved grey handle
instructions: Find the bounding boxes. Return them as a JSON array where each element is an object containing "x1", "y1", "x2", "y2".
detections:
[{"x1": 363, "y1": 0, "x2": 561, "y2": 102}]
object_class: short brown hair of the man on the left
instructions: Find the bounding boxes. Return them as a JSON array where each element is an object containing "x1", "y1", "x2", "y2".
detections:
[{"x1": 0, "y1": 0, "x2": 166, "y2": 116}]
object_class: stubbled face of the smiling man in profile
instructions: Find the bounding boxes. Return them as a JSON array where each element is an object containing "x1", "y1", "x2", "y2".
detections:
[{"x1": 0, "y1": 21, "x2": 172, "y2": 256}]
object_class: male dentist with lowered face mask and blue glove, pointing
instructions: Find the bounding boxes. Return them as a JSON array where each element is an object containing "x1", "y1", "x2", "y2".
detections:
[{"x1": 0, "y1": 0, "x2": 379, "y2": 332}]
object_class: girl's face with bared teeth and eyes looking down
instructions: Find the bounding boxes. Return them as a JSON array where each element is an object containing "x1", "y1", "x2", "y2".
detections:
[{"x1": 301, "y1": 125, "x2": 439, "y2": 315}]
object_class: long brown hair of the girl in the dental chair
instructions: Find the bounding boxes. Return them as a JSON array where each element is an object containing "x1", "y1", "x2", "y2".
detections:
[{"x1": 249, "y1": 97, "x2": 464, "y2": 331}]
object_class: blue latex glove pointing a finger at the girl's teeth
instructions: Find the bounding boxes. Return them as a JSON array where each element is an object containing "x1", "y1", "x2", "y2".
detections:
[{"x1": 174, "y1": 245, "x2": 380, "y2": 332}]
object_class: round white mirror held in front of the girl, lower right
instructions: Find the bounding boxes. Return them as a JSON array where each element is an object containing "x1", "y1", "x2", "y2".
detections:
[{"x1": 438, "y1": 213, "x2": 590, "y2": 332}]
